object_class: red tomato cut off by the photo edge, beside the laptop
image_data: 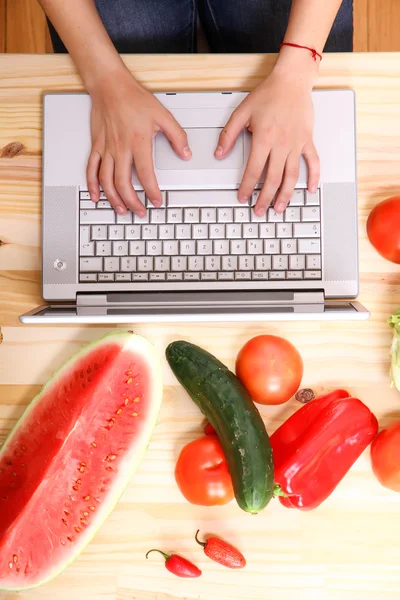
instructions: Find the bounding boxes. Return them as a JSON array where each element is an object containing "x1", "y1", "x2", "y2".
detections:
[{"x1": 367, "y1": 196, "x2": 400, "y2": 264}]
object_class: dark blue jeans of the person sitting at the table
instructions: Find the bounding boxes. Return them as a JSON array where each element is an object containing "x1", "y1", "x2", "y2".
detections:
[{"x1": 49, "y1": 0, "x2": 353, "y2": 54}]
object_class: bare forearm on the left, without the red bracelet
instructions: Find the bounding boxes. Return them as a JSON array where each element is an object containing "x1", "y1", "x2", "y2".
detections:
[{"x1": 39, "y1": 0, "x2": 125, "y2": 92}]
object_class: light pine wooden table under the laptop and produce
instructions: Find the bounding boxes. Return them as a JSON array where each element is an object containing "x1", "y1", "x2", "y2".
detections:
[{"x1": 0, "y1": 53, "x2": 400, "y2": 600}]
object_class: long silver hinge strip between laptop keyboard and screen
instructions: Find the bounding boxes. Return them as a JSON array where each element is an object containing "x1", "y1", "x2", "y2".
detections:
[{"x1": 76, "y1": 289, "x2": 325, "y2": 310}]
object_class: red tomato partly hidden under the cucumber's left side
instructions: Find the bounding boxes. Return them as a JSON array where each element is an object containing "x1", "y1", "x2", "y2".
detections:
[{"x1": 175, "y1": 434, "x2": 235, "y2": 506}]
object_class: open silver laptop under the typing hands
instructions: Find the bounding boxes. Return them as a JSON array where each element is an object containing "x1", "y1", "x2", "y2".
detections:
[{"x1": 20, "y1": 89, "x2": 369, "y2": 324}]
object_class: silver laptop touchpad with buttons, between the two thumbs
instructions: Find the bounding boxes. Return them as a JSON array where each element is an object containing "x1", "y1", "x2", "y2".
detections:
[{"x1": 155, "y1": 127, "x2": 244, "y2": 171}]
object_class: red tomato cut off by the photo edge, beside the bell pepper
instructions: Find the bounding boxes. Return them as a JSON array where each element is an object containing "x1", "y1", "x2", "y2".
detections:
[{"x1": 371, "y1": 422, "x2": 400, "y2": 492}]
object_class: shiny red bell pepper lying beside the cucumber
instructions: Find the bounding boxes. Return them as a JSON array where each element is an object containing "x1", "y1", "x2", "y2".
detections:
[{"x1": 271, "y1": 390, "x2": 378, "y2": 510}]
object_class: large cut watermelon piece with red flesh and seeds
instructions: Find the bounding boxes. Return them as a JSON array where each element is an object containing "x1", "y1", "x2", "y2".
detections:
[{"x1": 0, "y1": 332, "x2": 162, "y2": 590}]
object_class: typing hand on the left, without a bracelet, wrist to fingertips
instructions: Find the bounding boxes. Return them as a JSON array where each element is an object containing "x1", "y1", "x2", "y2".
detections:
[{"x1": 86, "y1": 69, "x2": 191, "y2": 216}]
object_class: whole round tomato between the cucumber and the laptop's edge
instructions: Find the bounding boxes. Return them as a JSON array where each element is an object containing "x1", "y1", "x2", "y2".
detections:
[{"x1": 236, "y1": 335, "x2": 303, "y2": 404}]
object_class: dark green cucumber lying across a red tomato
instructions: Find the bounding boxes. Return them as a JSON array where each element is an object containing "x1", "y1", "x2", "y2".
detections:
[{"x1": 166, "y1": 341, "x2": 274, "y2": 513}]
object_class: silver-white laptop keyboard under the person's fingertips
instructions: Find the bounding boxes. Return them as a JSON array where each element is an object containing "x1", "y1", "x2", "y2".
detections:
[{"x1": 79, "y1": 189, "x2": 321, "y2": 283}]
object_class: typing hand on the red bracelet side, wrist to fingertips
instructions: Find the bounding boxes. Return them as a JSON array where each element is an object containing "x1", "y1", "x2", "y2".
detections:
[{"x1": 215, "y1": 70, "x2": 319, "y2": 216}]
